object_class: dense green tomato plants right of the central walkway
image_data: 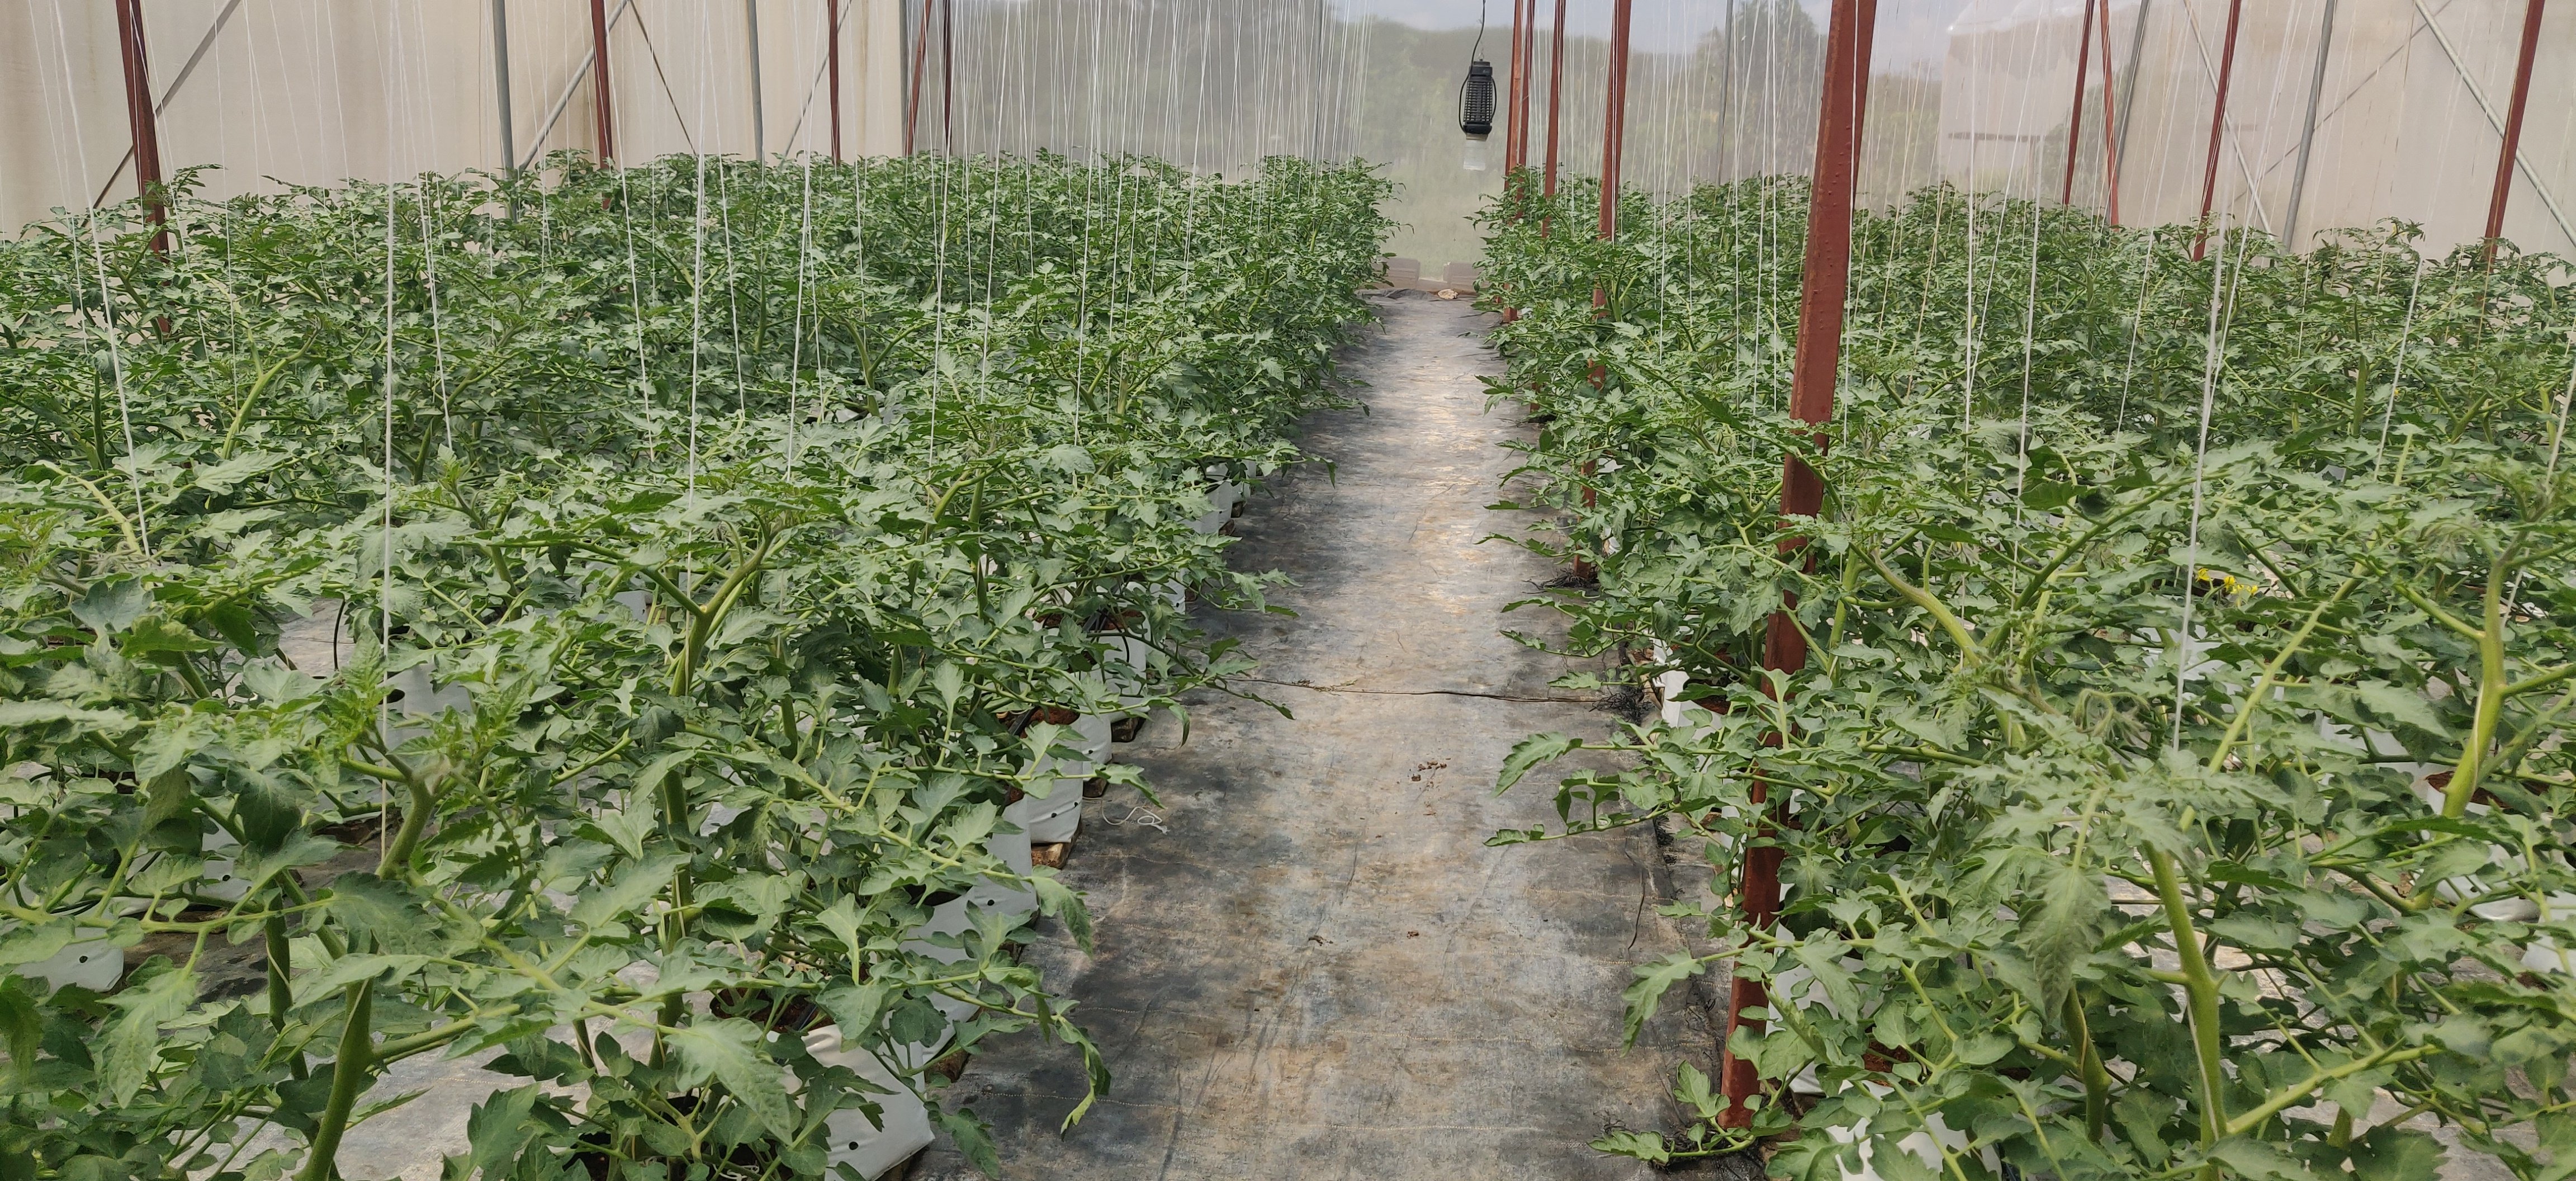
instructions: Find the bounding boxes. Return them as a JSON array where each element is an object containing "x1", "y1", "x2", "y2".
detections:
[{"x1": 1484, "y1": 178, "x2": 2576, "y2": 1181}]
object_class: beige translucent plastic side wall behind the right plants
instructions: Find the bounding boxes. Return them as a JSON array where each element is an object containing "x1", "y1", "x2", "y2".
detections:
[{"x1": 1937, "y1": 0, "x2": 2576, "y2": 253}]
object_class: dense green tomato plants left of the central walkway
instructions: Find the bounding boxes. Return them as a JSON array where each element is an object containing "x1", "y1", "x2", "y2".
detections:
[{"x1": 0, "y1": 157, "x2": 1386, "y2": 1181}]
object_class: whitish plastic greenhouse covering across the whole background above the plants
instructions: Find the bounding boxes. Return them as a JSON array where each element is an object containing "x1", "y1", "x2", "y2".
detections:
[{"x1": 15, "y1": 0, "x2": 2576, "y2": 273}]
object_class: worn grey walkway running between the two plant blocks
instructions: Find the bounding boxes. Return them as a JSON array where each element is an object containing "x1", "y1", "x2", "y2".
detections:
[{"x1": 912, "y1": 294, "x2": 1713, "y2": 1181}]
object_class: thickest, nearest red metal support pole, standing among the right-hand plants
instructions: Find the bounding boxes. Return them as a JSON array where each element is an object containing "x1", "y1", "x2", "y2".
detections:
[{"x1": 1718, "y1": 0, "x2": 1878, "y2": 1127}]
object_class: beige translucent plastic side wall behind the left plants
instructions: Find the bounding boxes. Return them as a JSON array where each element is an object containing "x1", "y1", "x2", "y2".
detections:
[{"x1": 0, "y1": 0, "x2": 902, "y2": 229}]
